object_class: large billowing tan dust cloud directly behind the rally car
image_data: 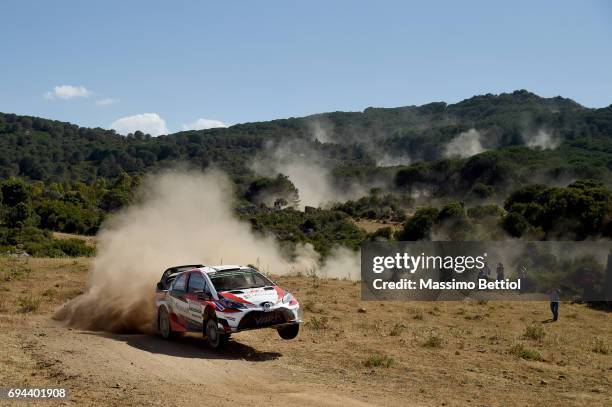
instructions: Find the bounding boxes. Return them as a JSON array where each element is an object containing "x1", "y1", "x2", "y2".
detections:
[{"x1": 55, "y1": 171, "x2": 359, "y2": 332}]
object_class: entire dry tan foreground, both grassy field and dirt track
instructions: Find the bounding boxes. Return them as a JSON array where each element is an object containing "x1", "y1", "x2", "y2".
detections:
[{"x1": 0, "y1": 258, "x2": 612, "y2": 406}]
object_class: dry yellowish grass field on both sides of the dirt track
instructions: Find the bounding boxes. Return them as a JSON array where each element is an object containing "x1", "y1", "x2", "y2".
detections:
[{"x1": 0, "y1": 258, "x2": 612, "y2": 406}]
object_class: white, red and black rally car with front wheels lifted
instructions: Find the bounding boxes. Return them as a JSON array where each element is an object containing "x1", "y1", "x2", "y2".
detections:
[{"x1": 156, "y1": 264, "x2": 302, "y2": 348}]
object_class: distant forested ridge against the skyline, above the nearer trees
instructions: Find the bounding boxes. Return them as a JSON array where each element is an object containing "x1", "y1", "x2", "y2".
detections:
[{"x1": 0, "y1": 91, "x2": 612, "y2": 186}]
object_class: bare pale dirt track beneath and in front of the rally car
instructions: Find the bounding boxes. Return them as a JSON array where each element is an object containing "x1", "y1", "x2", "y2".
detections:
[{"x1": 4, "y1": 317, "x2": 374, "y2": 406}]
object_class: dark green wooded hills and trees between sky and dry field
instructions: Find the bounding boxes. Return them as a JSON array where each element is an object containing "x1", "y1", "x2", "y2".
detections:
[{"x1": 0, "y1": 90, "x2": 612, "y2": 255}]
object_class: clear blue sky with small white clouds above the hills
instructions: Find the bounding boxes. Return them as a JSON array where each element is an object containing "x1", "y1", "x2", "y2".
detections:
[{"x1": 0, "y1": 0, "x2": 612, "y2": 132}]
